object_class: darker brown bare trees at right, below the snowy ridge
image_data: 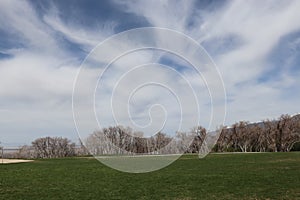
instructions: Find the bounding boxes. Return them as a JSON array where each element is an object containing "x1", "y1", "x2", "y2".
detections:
[{"x1": 213, "y1": 115, "x2": 300, "y2": 152}]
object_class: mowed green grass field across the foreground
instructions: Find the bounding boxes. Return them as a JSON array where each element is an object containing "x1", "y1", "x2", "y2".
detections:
[{"x1": 0, "y1": 153, "x2": 300, "y2": 200}]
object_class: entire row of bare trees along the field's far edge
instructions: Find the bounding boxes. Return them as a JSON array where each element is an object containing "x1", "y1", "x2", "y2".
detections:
[{"x1": 4, "y1": 115, "x2": 300, "y2": 158}]
